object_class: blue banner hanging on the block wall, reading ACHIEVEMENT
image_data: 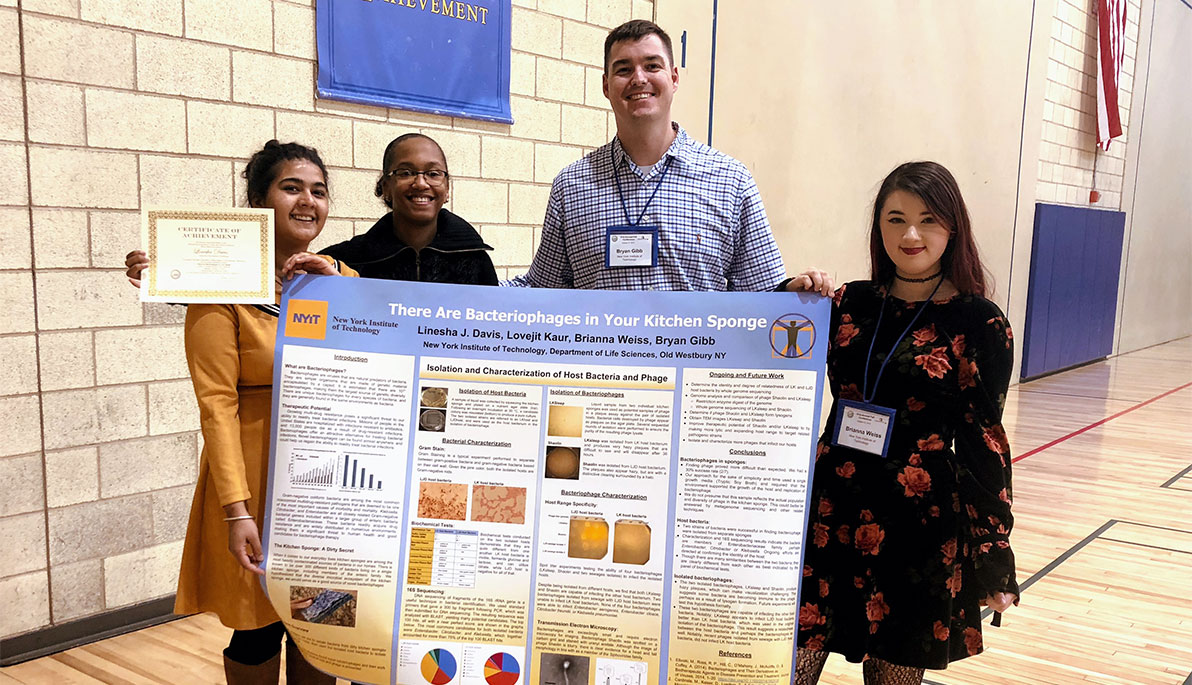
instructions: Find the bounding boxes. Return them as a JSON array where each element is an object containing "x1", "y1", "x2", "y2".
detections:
[{"x1": 317, "y1": 0, "x2": 513, "y2": 124}]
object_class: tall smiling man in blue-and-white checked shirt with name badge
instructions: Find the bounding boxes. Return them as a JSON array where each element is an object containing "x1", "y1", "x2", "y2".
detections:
[{"x1": 507, "y1": 19, "x2": 832, "y2": 294}]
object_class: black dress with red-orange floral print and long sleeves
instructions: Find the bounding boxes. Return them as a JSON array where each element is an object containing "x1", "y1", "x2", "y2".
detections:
[{"x1": 799, "y1": 281, "x2": 1018, "y2": 668}]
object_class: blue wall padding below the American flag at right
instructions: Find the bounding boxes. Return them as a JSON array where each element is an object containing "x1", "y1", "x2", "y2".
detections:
[{"x1": 1022, "y1": 203, "x2": 1125, "y2": 379}]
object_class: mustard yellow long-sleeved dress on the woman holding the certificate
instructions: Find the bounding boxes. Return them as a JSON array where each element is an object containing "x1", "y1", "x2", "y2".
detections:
[{"x1": 174, "y1": 265, "x2": 356, "y2": 630}]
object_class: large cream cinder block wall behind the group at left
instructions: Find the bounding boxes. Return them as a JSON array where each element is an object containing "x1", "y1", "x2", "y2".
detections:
[{"x1": 0, "y1": 0, "x2": 653, "y2": 637}]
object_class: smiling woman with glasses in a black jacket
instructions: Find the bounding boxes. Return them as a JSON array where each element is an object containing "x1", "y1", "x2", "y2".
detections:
[{"x1": 323, "y1": 133, "x2": 497, "y2": 286}]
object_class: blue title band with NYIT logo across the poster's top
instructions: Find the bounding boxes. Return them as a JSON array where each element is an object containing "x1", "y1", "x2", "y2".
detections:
[{"x1": 285, "y1": 280, "x2": 827, "y2": 369}]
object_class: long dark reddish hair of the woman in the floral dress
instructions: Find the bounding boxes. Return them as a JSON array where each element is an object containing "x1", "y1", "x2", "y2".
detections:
[{"x1": 869, "y1": 162, "x2": 986, "y2": 295}]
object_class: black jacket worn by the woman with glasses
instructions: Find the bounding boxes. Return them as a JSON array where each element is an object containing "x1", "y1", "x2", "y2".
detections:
[{"x1": 322, "y1": 210, "x2": 498, "y2": 286}]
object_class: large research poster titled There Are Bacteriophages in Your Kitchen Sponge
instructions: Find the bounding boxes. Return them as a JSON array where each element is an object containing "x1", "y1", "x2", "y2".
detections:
[{"x1": 263, "y1": 276, "x2": 831, "y2": 685}]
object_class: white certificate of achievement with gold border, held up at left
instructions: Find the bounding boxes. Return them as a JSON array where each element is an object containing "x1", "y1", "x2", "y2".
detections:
[{"x1": 141, "y1": 207, "x2": 275, "y2": 304}]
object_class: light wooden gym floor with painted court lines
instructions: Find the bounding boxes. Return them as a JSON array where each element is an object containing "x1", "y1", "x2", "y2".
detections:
[{"x1": 0, "y1": 337, "x2": 1192, "y2": 685}]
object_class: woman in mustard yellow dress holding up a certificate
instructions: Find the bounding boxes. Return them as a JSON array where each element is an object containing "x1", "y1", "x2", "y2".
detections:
[{"x1": 174, "y1": 141, "x2": 356, "y2": 685}]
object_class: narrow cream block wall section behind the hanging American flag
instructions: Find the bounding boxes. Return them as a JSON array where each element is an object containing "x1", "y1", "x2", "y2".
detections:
[{"x1": 1035, "y1": 0, "x2": 1142, "y2": 210}]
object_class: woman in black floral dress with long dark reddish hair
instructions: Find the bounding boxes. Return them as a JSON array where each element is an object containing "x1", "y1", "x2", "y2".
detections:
[{"x1": 795, "y1": 162, "x2": 1018, "y2": 685}]
